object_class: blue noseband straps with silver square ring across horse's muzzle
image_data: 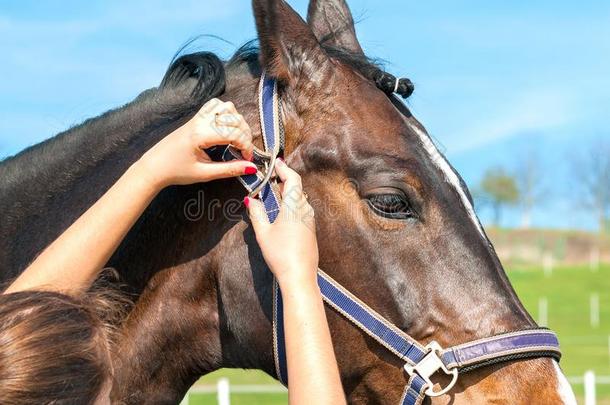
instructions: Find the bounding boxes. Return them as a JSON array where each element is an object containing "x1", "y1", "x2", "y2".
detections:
[{"x1": 318, "y1": 270, "x2": 561, "y2": 405}]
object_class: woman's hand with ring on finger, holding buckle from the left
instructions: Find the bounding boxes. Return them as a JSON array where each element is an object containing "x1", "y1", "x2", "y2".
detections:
[{"x1": 136, "y1": 99, "x2": 256, "y2": 188}]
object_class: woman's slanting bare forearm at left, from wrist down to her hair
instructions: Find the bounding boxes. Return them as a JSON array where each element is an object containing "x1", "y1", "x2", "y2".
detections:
[{"x1": 5, "y1": 162, "x2": 160, "y2": 294}]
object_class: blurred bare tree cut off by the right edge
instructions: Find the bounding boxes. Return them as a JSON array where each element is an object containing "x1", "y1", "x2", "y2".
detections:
[{"x1": 572, "y1": 138, "x2": 610, "y2": 233}]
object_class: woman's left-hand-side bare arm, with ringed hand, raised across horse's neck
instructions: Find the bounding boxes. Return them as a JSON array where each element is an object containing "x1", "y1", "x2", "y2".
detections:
[{"x1": 5, "y1": 99, "x2": 256, "y2": 294}]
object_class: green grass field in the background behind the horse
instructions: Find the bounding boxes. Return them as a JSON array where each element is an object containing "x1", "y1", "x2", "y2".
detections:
[{"x1": 189, "y1": 265, "x2": 610, "y2": 405}]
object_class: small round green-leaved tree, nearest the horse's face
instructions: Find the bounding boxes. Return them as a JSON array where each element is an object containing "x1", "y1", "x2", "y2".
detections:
[{"x1": 478, "y1": 167, "x2": 519, "y2": 226}]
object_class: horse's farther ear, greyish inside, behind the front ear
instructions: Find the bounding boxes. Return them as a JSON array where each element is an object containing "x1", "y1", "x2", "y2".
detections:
[{"x1": 307, "y1": 0, "x2": 364, "y2": 55}]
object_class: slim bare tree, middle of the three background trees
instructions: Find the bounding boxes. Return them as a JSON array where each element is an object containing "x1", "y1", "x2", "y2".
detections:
[{"x1": 515, "y1": 150, "x2": 544, "y2": 228}]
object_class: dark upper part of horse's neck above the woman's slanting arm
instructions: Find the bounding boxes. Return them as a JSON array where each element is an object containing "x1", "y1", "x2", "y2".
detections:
[{"x1": 0, "y1": 86, "x2": 203, "y2": 280}]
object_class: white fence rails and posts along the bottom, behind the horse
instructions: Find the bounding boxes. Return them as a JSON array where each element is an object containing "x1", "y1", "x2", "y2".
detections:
[{"x1": 180, "y1": 371, "x2": 610, "y2": 405}]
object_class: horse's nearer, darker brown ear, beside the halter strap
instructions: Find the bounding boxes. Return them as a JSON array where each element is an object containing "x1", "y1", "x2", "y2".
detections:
[{"x1": 252, "y1": 0, "x2": 330, "y2": 83}]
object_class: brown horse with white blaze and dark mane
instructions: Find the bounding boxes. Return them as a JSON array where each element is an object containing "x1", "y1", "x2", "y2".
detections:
[{"x1": 0, "y1": 0, "x2": 575, "y2": 404}]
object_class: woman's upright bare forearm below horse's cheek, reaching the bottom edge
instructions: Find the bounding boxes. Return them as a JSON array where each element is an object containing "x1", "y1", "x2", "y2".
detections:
[{"x1": 280, "y1": 279, "x2": 345, "y2": 405}]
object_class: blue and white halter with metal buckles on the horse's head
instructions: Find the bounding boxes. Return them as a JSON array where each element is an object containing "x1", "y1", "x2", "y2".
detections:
[{"x1": 210, "y1": 73, "x2": 561, "y2": 405}]
